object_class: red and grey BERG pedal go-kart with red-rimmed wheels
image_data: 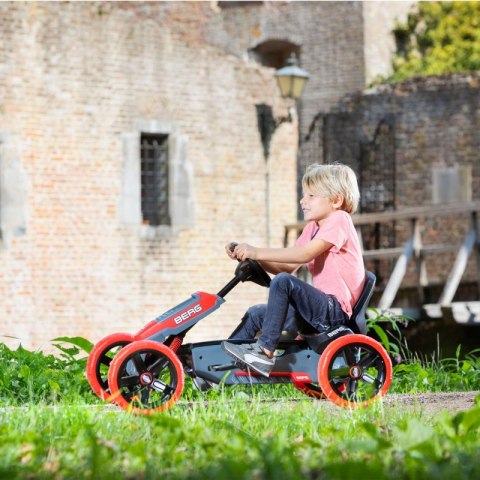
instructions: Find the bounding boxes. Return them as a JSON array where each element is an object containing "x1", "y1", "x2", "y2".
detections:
[{"x1": 87, "y1": 253, "x2": 392, "y2": 414}]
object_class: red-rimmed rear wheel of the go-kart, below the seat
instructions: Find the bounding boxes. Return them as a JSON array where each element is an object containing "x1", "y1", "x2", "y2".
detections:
[{"x1": 318, "y1": 335, "x2": 392, "y2": 407}]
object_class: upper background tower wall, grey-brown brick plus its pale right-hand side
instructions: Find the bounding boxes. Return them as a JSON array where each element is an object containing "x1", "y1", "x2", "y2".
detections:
[{"x1": 206, "y1": 1, "x2": 416, "y2": 181}]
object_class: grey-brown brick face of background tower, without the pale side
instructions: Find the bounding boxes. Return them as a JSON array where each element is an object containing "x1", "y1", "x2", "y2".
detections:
[{"x1": 204, "y1": 2, "x2": 366, "y2": 176}]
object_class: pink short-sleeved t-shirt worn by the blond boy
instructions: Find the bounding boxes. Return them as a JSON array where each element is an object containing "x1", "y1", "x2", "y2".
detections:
[{"x1": 295, "y1": 210, "x2": 365, "y2": 316}]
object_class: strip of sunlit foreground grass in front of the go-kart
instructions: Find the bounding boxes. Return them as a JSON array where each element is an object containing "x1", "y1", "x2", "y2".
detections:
[{"x1": 0, "y1": 398, "x2": 480, "y2": 480}]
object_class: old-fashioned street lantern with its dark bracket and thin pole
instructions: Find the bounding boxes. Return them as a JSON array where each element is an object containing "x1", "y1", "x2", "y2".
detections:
[{"x1": 257, "y1": 53, "x2": 310, "y2": 246}]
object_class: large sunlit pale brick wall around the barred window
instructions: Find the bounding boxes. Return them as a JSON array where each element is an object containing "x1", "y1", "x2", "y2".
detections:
[{"x1": 0, "y1": 2, "x2": 297, "y2": 347}]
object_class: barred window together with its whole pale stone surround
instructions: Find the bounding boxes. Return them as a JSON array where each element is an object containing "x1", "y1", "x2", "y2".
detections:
[{"x1": 119, "y1": 118, "x2": 195, "y2": 239}]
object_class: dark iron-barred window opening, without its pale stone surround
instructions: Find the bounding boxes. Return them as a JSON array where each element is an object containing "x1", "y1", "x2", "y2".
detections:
[{"x1": 140, "y1": 133, "x2": 170, "y2": 226}]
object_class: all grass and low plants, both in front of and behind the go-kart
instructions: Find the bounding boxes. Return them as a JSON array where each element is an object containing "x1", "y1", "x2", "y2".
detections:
[{"x1": 0, "y1": 325, "x2": 480, "y2": 480}]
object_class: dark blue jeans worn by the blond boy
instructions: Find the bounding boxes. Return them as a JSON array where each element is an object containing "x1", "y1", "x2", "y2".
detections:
[{"x1": 230, "y1": 273, "x2": 348, "y2": 351}]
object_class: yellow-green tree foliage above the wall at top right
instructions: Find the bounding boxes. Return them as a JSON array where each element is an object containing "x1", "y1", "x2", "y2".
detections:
[{"x1": 387, "y1": 2, "x2": 480, "y2": 82}]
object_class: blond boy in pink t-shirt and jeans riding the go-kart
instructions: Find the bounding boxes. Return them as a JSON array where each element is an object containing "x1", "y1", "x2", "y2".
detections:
[{"x1": 222, "y1": 164, "x2": 365, "y2": 377}]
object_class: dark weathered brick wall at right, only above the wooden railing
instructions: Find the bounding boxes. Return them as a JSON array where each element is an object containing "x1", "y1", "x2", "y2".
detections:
[{"x1": 325, "y1": 73, "x2": 480, "y2": 208}]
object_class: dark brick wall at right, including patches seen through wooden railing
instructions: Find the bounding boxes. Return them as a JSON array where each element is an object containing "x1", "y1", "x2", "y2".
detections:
[{"x1": 320, "y1": 73, "x2": 480, "y2": 284}]
